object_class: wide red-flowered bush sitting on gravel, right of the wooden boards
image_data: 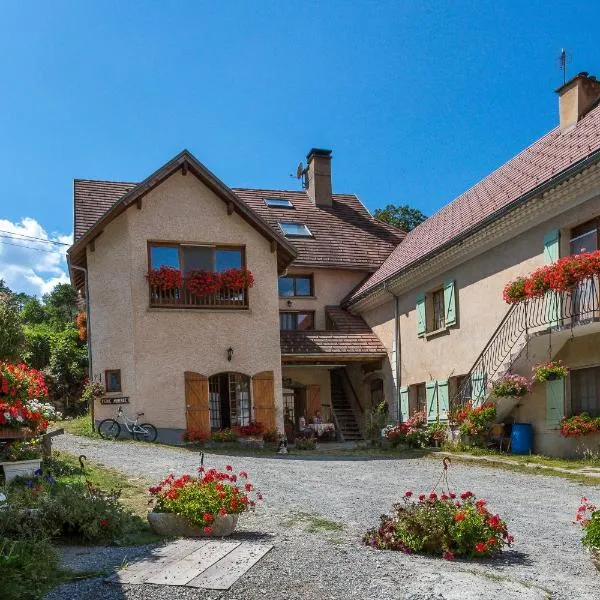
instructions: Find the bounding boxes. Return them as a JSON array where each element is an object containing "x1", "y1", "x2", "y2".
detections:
[{"x1": 363, "y1": 490, "x2": 514, "y2": 560}]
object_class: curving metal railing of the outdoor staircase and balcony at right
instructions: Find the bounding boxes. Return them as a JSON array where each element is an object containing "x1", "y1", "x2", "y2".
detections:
[{"x1": 451, "y1": 276, "x2": 600, "y2": 407}]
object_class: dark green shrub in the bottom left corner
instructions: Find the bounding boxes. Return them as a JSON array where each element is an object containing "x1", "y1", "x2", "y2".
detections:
[{"x1": 0, "y1": 537, "x2": 60, "y2": 600}]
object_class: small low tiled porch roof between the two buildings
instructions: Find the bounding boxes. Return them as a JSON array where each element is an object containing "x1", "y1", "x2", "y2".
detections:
[{"x1": 280, "y1": 306, "x2": 386, "y2": 362}]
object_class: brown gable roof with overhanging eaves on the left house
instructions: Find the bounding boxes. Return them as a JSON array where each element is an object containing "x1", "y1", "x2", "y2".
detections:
[{"x1": 68, "y1": 150, "x2": 296, "y2": 282}]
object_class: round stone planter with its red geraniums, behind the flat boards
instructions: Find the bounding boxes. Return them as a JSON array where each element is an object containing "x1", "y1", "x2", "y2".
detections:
[{"x1": 148, "y1": 465, "x2": 262, "y2": 537}]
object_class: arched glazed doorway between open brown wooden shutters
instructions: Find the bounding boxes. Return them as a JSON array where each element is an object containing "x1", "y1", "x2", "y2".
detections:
[{"x1": 208, "y1": 372, "x2": 252, "y2": 429}]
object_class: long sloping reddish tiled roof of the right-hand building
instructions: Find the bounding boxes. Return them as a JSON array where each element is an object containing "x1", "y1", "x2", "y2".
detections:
[{"x1": 350, "y1": 102, "x2": 600, "y2": 303}]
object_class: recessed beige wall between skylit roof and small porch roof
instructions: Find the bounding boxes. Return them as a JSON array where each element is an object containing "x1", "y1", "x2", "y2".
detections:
[{"x1": 279, "y1": 268, "x2": 367, "y2": 329}]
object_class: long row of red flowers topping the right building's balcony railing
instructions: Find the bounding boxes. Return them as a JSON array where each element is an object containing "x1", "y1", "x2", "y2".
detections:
[{"x1": 502, "y1": 250, "x2": 600, "y2": 304}]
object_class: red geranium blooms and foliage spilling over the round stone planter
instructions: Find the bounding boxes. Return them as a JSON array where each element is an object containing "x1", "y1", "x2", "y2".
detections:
[{"x1": 149, "y1": 465, "x2": 263, "y2": 535}]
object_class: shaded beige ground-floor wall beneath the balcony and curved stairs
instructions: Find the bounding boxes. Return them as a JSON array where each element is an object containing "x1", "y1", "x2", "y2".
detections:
[{"x1": 512, "y1": 332, "x2": 600, "y2": 456}]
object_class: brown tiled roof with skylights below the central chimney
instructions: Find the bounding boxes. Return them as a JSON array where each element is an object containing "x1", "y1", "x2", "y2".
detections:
[{"x1": 233, "y1": 188, "x2": 405, "y2": 271}]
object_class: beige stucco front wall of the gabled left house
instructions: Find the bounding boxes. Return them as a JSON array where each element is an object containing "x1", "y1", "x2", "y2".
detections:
[{"x1": 88, "y1": 172, "x2": 282, "y2": 429}]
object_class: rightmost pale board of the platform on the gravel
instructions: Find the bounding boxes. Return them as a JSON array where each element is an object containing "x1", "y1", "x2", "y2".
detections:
[{"x1": 186, "y1": 544, "x2": 273, "y2": 590}]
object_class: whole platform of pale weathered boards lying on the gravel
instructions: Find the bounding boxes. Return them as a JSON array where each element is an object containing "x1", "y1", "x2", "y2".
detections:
[{"x1": 106, "y1": 539, "x2": 273, "y2": 590}]
